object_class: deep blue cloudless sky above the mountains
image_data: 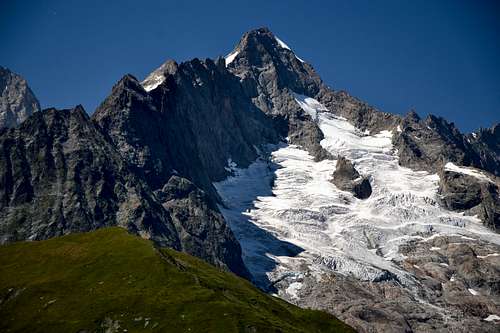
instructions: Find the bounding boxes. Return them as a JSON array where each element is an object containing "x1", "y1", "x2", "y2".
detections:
[{"x1": 0, "y1": 0, "x2": 500, "y2": 131}]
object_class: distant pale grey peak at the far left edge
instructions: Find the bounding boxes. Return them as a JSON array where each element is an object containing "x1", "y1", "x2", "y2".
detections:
[{"x1": 0, "y1": 66, "x2": 40, "y2": 129}]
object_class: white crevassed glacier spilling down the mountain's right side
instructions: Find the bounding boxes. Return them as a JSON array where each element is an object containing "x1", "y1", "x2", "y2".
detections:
[{"x1": 215, "y1": 95, "x2": 500, "y2": 330}]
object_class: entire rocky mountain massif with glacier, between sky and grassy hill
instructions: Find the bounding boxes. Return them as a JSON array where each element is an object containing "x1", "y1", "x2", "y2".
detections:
[{"x1": 0, "y1": 28, "x2": 500, "y2": 332}]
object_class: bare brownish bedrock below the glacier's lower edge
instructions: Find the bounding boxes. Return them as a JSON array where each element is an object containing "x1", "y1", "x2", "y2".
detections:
[{"x1": 282, "y1": 236, "x2": 500, "y2": 333}]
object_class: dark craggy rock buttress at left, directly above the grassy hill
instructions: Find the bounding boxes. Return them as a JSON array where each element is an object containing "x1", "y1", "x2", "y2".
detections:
[{"x1": 0, "y1": 106, "x2": 180, "y2": 248}]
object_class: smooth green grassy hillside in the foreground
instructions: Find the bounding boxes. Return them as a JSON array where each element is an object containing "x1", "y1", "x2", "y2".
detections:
[{"x1": 0, "y1": 228, "x2": 351, "y2": 332}]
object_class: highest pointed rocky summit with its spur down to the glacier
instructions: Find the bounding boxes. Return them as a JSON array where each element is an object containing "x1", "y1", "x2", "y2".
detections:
[{"x1": 226, "y1": 28, "x2": 330, "y2": 160}]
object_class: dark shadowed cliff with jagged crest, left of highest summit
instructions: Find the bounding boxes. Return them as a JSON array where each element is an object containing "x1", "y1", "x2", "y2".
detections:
[{"x1": 93, "y1": 59, "x2": 279, "y2": 199}]
